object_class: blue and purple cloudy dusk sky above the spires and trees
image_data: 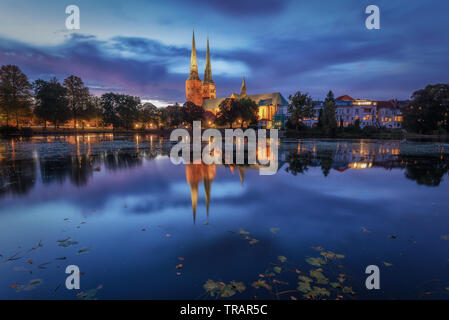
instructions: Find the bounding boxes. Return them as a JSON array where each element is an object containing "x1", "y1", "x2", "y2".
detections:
[{"x1": 0, "y1": 0, "x2": 449, "y2": 106}]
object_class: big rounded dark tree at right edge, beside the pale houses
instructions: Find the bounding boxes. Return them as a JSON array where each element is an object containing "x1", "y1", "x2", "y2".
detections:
[{"x1": 403, "y1": 84, "x2": 449, "y2": 133}]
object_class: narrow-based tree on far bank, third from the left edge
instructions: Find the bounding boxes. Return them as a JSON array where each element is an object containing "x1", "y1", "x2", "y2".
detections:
[{"x1": 64, "y1": 75, "x2": 89, "y2": 129}]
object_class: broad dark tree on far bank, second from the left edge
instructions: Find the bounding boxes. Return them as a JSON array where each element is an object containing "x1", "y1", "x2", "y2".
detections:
[{"x1": 33, "y1": 78, "x2": 71, "y2": 129}]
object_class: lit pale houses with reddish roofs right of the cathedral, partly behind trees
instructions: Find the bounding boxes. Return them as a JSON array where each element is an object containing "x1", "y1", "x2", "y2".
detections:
[{"x1": 273, "y1": 95, "x2": 408, "y2": 129}]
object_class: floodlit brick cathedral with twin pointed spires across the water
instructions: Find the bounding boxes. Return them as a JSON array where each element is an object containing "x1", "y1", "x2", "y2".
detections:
[{"x1": 186, "y1": 32, "x2": 288, "y2": 128}]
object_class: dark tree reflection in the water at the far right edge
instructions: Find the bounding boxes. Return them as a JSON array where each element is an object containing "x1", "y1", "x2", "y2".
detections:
[{"x1": 401, "y1": 155, "x2": 449, "y2": 187}]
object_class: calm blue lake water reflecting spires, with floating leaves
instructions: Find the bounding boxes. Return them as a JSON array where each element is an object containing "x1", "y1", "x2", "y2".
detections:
[{"x1": 0, "y1": 135, "x2": 449, "y2": 299}]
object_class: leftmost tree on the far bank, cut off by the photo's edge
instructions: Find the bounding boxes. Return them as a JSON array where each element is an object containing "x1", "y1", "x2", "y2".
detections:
[{"x1": 0, "y1": 65, "x2": 32, "y2": 127}]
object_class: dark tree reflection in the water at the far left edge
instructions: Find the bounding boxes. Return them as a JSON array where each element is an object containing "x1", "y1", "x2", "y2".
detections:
[{"x1": 0, "y1": 159, "x2": 36, "y2": 196}]
